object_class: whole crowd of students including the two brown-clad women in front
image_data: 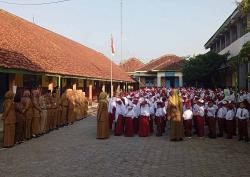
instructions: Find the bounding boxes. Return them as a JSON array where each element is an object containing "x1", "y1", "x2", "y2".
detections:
[{"x1": 97, "y1": 88, "x2": 250, "y2": 142}]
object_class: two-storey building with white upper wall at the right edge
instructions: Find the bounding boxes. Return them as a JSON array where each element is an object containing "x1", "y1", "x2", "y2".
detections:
[{"x1": 205, "y1": 8, "x2": 250, "y2": 88}]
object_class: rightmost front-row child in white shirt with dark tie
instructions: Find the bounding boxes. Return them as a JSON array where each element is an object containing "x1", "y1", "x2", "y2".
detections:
[{"x1": 236, "y1": 102, "x2": 249, "y2": 142}]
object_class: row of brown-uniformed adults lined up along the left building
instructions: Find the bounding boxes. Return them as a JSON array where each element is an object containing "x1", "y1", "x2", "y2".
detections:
[{"x1": 2, "y1": 89, "x2": 88, "y2": 148}]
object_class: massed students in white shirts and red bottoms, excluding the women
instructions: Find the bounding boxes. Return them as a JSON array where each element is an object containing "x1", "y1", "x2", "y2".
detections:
[{"x1": 108, "y1": 88, "x2": 249, "y2": 141}]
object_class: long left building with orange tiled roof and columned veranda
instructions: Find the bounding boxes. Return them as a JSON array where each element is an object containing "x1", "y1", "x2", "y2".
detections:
[{"x1": 0, "y1": 10, "x2": 134, "y2": 114}]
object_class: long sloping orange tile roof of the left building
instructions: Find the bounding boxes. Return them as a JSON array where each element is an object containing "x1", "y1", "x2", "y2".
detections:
[{"x1": 0, "y1": 10, "x2": 133, "y2": 82}]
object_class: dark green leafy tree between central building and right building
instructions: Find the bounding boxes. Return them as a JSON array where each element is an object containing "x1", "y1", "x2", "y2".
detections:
[{"x1": 183, "y1": 52, "x2": 227, "y2": 87}]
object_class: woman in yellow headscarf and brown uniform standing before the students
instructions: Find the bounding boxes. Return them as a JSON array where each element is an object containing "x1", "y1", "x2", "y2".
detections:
[{"x1": 168, "y1": 89, "x2": 184, "y2": 141}]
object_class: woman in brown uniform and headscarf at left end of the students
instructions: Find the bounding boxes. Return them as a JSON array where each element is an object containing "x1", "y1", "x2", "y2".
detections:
[{"x1": 97, "y1": 92, "x2": 109, "y2": 139}]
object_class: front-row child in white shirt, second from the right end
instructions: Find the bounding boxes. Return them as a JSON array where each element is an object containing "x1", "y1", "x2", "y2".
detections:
[{"x1": 226, "y1": 103, "x2": 235, "y2": 139}]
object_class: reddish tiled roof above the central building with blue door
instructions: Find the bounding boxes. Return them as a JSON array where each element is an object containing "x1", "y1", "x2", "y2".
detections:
[{"x1": 137, "y1": 55, "x2": 184, "y2": 72}]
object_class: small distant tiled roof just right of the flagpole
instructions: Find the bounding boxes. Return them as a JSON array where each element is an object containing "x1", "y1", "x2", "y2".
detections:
[{"x1": 120, "y1": 58, "x2": 145, "y2": 72}]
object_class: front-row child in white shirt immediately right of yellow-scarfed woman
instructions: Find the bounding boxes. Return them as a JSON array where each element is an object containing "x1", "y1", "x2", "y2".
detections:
[{"x1": 182, "y1": 101, "x2": 193, "y2": 138}]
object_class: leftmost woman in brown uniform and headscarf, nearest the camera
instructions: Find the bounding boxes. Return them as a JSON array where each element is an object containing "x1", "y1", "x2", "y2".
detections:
[{"x1": 2, "y1": 91, "x2": 16, "y2": 148}]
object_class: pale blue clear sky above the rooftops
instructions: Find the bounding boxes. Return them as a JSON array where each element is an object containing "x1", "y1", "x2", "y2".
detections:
[{"x1": 0, "y1": 0, "x2": 239, "y2": 63}]
